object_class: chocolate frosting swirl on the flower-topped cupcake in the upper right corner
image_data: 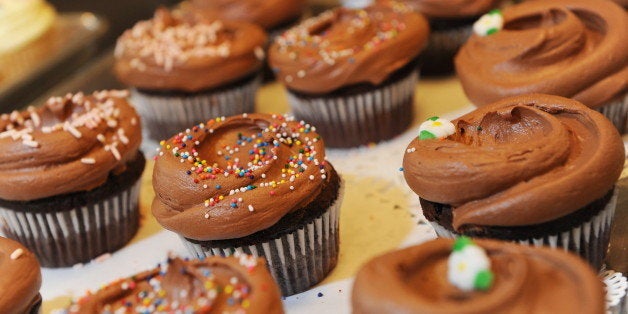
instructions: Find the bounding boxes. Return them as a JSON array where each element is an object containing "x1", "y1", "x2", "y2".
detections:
[{"x1": 455, "y1": 0, "x2": 628, "y2": 107}]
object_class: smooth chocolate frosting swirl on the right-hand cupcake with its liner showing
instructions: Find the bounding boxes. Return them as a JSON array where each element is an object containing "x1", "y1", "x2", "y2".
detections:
[{"x1": 403, "y1": 94, "x2": 624, "y2": 230}]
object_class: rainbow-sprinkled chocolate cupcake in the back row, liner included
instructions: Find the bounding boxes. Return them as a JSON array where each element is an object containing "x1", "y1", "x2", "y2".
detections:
[{"x1": 269, "y1": 3, "x2": 429, "y2": 147}]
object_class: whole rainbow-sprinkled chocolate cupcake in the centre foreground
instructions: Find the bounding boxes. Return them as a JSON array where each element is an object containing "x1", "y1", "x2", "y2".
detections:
[{"x1": 152, "y1": 114, "x2": 342, "y2": 296}]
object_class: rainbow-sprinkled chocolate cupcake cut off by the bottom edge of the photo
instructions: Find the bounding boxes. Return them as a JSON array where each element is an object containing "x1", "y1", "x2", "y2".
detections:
[{"x1": 67, "y1": 255, "x2": 283, "y2": 314}]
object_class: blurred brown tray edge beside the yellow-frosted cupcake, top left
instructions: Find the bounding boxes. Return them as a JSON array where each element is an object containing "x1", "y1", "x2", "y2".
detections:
[{"x1": 0, "y1": 12, "x2": 107, "y2": 112}]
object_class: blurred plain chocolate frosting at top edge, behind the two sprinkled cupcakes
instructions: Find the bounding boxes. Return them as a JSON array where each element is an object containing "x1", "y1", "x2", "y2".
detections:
[{"x1": 181, "y1": 0, "x2": 305, "y2": 30}]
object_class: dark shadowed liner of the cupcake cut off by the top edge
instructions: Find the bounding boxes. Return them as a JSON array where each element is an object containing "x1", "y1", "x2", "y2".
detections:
[{"x1": 421, "y1": 24, "x2": 473, "y2": 76}]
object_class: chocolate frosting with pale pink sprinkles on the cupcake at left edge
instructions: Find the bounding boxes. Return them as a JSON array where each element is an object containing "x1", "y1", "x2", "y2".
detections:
[{"x1": 0, "y1": 91, "x2": 142, "y2": 201}]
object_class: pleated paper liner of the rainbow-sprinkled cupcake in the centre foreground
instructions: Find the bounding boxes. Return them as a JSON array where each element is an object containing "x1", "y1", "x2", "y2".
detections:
[{"x1": 181, "y1": 183, "x2": 344, "y2": 297}]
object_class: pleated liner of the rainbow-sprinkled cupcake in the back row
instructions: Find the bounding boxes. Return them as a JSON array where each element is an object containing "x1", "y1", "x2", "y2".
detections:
[{"x1": 288, "y1": 71, "x2": 418, "y2": 147}]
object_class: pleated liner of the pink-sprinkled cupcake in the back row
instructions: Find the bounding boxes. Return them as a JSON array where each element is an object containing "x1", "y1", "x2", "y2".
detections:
[{"x1": 131, "y1": 77, "x2": 261, "y2": 141}]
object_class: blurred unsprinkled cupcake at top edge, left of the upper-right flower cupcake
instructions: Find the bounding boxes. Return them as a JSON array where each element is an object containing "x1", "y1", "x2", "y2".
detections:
[{"x1": 388, "y1": 0, "x2": 504, "y2": 75}]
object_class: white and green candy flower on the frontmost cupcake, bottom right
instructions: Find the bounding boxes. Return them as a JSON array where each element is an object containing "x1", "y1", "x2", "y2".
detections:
[{"x1": 447, "y1": 236, "x2": 494, "y2": 291}]
